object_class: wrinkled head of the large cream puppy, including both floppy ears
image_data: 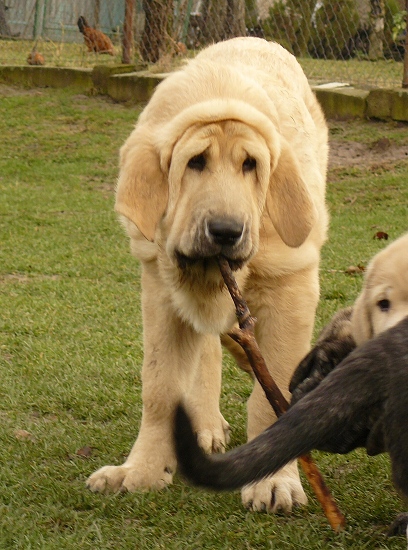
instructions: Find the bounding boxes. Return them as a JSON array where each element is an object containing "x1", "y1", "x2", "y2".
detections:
[{"x1": 116, "y1": 99, "x2": 317, "y2": 267}]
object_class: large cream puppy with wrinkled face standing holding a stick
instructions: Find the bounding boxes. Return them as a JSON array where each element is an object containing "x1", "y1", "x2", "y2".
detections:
[{"x1": 88, "y1": 38, "x2": 328, "y2": 510}]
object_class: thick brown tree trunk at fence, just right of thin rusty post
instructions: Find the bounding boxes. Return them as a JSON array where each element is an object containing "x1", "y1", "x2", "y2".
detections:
[{"x1": 139, "y1": 0, "x2": 173, "y2": 63}]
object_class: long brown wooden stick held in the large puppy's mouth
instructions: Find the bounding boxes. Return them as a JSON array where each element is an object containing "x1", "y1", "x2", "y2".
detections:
[{"x1": 217, "y1": 256, "x2": 346, "y2": 531}]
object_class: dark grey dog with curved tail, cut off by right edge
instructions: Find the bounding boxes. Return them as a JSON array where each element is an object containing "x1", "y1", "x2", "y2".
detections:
[{"x1": 174, "y1": 317, "x2": 408, "y2": 534}]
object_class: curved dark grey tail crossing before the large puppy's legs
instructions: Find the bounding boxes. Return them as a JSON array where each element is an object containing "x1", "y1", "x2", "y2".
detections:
[{"x1": 174, "y1": 405, "x2": 314, "y2": 490}]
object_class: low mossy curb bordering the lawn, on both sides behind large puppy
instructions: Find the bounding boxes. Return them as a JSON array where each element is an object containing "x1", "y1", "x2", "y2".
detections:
[{"x1": 0, "y1": 65, "x2": 408, "y2": 122}]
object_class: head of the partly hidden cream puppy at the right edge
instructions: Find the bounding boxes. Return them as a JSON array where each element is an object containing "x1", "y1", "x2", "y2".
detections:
[{"x1": 352, "y1": 233, "x2": 408, "y2": 345}]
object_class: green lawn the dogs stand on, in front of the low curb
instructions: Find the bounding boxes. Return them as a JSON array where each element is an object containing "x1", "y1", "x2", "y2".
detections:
[{"x1": 0, "y1": 87, "x2": 408, "y2": 550}]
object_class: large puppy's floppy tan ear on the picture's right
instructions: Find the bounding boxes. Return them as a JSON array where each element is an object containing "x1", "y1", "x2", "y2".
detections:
[{"x1": 266, "y1": 140, "x2": 318, "y2": 247}]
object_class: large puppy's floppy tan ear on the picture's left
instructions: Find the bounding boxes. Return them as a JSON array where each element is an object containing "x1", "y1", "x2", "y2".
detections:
[{"x1": 115, "y1": 136, "x2": 168, "y2": 241}]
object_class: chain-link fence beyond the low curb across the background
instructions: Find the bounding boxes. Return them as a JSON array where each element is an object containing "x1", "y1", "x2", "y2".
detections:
[{"x1": 0, "y1": 0, "x2": 408, "y2": 87}]
